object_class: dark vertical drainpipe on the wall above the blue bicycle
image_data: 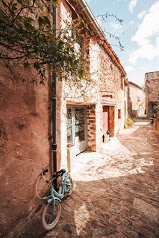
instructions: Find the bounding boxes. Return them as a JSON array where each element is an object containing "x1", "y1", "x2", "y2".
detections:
[{"x1": 51, "y1": 6, "x2": 57, "y2": 187}]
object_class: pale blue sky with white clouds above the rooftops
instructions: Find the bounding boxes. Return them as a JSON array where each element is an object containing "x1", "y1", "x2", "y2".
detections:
[{"x1": 85, "y1": 0, "x2": 159, "y2": 86}]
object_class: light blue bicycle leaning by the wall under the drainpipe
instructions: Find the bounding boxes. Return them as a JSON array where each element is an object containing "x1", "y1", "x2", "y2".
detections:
[{"x1": 36, "y1": 169, "x2": 73, "y2": 231}]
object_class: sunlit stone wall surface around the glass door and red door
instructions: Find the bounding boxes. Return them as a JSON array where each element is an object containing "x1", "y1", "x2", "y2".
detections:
[{"x1": 57, "y1": 2, "x2": 127, "y2": 168}]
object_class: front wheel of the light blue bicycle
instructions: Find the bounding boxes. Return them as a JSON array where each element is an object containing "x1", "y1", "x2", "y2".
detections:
[{"x1": 42, "y1": 200, "x2": 61, "y2": 231}]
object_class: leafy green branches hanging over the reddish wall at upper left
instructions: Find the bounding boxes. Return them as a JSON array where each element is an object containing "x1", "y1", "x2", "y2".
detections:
[{"x1": 0, "y1": 0, "x2": 84, "y2": 82}]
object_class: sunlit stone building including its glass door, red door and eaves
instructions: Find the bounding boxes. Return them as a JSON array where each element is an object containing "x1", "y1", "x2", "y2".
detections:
[{"x1": 57, "y1": 1, "x2": 127, "y2": 169}]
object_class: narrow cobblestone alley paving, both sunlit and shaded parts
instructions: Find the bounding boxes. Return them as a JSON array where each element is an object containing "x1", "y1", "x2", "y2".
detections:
[{"x1": 19, "y1": 120, "x2": 159, "y2": 238}]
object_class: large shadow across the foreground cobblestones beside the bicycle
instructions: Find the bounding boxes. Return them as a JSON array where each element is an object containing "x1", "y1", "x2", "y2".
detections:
[{"x1": 18, "y1": 165, "x2": 159, "y2": 238}]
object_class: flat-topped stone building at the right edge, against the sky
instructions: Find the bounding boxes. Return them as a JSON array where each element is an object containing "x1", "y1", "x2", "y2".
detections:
[{"x1": 145, "y1": 71, "x2": 159, "y2": 118}]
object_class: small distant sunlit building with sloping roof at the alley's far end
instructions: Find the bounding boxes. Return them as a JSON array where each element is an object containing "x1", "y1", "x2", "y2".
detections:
[{"x1": 128, "y1": 82, "x2": 145, "y2": 117}]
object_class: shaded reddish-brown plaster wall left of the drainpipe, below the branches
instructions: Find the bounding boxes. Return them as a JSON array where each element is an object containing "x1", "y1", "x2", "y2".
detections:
[{"x1": 0, "y1": 64, "x2": 49, "y2": 237}]
